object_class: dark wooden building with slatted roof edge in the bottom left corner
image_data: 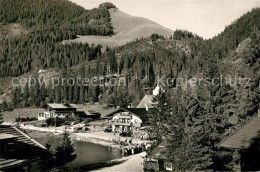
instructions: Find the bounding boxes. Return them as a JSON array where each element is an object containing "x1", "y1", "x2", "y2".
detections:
[{"x1": 0, "y1": 125, "x2": 47, "y2": 171}]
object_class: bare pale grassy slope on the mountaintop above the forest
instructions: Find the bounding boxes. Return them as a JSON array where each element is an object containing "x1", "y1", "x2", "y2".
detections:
[{"x1": 64, "y1": 9, "x2": 173, "y2": 47}]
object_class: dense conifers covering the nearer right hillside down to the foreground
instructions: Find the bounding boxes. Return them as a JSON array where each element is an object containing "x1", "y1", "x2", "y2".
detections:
[{"x1": 153, "y1": 33, "x2": 260, "y2": 171}]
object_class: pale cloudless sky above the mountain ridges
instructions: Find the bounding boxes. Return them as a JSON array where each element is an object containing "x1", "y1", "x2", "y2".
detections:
[{"x1": 71, "y1": 0, "x2": 260, "y2": 38}]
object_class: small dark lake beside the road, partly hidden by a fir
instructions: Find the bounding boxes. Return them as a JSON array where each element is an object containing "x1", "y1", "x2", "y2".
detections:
[{"x1": 32, "y1": 134, "x2": 122, "y2": 169}]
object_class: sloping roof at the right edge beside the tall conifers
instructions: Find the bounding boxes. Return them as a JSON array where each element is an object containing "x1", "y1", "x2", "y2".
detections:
[{"x1": 220, "y1": 116, "x2": 260, "y2": 149}]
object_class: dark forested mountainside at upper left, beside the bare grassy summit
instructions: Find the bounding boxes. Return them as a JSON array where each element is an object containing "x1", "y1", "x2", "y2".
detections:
[{"x1": 0, "y1": 0, "x2": 115, "y2": 77}]
